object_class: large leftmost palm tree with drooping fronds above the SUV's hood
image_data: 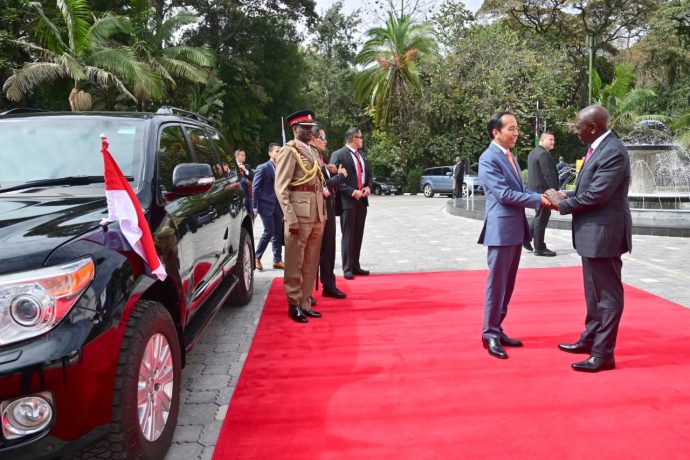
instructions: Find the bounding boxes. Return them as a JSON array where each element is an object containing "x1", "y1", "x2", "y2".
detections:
[{"x1": 3, "y1": 0, "x2": 161, "y2": 110}]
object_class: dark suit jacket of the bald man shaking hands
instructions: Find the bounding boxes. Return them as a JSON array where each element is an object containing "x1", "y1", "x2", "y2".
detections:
[{"x1": 560, "y1": 133, "x2": 632, "y2": 258}]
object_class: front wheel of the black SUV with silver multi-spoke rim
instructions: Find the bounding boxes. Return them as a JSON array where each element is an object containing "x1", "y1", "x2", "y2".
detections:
[{"x1": 109, "y1": 300, "x2": 181, "y2": 460}]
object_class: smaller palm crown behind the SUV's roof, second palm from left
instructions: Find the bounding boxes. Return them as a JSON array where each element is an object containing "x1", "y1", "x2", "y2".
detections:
[{"x1": 130, "y1": 9, "x2": 215, "y2": 103}]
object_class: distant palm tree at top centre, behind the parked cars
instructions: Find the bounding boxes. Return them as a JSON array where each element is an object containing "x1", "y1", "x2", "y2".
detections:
[{"x1": 354, "y1": 13, "x2": 436, "y2": 126}]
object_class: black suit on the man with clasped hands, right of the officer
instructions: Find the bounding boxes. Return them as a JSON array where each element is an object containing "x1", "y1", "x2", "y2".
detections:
[{"x1": 331, "y1": 146, "x2": 373, "y2": 274}]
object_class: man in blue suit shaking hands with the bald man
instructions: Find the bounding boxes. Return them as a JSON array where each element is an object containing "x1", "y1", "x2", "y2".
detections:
[{"x1": 479, "y1": 112, "x2": 549, "y2": 359}]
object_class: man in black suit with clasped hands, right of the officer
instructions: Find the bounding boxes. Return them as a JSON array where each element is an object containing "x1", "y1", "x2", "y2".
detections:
[{"x1": 331, "y1": 128, "x2": 373, "y2": 280}]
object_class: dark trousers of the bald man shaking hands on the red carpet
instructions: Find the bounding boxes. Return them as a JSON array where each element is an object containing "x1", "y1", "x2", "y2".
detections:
[{"x1": 580, "y1": 256, "x2": 623, "y2": 359}]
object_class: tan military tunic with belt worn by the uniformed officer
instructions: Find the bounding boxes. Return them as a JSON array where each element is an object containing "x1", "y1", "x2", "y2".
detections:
[{"x1": 274, "y1": 141, "x2": 326, "y2": 225}]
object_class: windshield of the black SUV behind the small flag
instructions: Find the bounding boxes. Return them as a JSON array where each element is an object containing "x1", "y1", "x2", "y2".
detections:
[{"x1": 0, "y1": 116, "x2": 144, "y2": 191}]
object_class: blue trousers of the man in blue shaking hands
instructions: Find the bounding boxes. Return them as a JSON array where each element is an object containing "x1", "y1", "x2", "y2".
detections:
[{"x1": 482, "y1": 244, "x2": 522, "y2": 339}]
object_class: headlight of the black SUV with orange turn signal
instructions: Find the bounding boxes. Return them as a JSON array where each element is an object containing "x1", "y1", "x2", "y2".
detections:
[{"x1": 0, "y1": 258, "x2": 95, "y2": 346}]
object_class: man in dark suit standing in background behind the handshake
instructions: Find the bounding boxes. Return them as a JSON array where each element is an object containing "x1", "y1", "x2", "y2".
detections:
[{"x1": 523, "y1": 131, "x2": 558, "y2": 257}]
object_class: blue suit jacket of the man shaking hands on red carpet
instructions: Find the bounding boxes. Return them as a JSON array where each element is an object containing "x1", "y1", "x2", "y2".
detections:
[{"x1": 478, "y1": 142, "x2": 541, "y2": 246}]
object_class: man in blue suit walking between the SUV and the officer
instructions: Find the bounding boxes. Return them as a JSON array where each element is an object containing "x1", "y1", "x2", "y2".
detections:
[{"x1": 252, "y1": 144, "x2": 285, "y2": 270}]
